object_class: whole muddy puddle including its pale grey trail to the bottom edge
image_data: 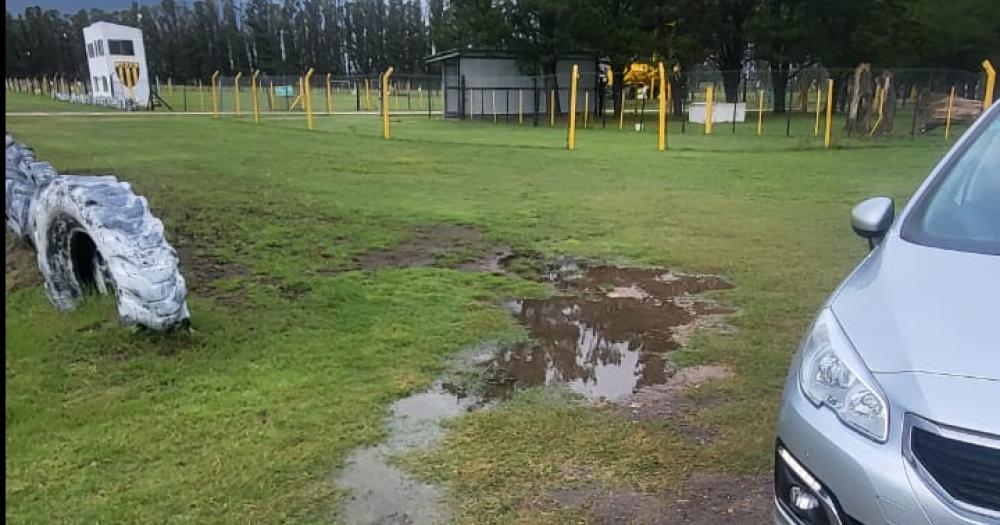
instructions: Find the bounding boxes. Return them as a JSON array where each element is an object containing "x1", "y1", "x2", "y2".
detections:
[{"x1": 334, "y1": 259, "x2": 730, "y2": 525}]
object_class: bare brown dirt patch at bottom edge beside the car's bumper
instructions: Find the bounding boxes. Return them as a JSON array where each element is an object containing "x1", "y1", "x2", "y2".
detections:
[{"x1": 523, "y1": 473, "x2": 772, "y2": 525}]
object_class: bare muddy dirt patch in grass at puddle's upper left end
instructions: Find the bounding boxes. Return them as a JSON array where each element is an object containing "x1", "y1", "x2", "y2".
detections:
[{"x1": 359, "y1": 224, "x2": 514, "y2": 272}]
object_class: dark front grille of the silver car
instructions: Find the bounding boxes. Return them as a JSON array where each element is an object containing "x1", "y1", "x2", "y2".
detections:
[{"x1": 910, "y1": 427, "x2": 1000, "y2": 512}]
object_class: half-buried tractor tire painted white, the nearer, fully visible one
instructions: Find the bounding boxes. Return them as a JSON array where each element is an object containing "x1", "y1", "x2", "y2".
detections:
[{"x1": 29, "y1": 176, "x2": 190, "y2": 330}]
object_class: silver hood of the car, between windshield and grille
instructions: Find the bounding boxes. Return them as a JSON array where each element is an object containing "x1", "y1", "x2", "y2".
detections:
[{"x1": 830, "y1": 236, "x2": 1000, "y2": 380}]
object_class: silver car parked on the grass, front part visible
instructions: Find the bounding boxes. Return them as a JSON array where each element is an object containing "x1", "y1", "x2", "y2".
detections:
[{"x1": 774, "y1": 100, "x2": 1000, "y2": 525}]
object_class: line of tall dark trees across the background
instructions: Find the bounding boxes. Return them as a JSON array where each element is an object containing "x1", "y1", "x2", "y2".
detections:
[{"x1": 6, "y1": 0, "x2": 1000, "y2": 108}]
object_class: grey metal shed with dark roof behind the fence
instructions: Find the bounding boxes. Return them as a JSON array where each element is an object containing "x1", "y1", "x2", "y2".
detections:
[{"x1": 425, "y1": 49, "x2": 601, "y2": 118}]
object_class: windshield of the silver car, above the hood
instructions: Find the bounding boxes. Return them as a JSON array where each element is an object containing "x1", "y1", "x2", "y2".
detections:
[{"x1": 902, "y1": 112, "x2": 1000, "y2": 255}]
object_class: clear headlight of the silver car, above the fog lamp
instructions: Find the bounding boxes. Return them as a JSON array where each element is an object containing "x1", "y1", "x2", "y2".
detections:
[{"x1": 799, "y1": 308, "x2": 889, "y2": 442}]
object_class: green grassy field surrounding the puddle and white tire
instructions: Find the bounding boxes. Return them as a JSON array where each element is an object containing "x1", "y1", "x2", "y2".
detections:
[{"x1": 5, "y1": 94, "x2": 947, "y2": 523}]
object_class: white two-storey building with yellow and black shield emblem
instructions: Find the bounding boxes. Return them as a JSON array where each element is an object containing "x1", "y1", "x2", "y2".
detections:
[{"x1": 83, "y1": 22, "x2": 149, "y2": 106}]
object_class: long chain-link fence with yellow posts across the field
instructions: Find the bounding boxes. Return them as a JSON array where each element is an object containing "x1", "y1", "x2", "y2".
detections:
[{"x1": 7, "y1": 64, "x2": 986, "y2": 148}]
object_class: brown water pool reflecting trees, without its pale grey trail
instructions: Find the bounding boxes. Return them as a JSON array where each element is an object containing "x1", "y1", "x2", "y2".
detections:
[{"x1": 490, "y1": 264, "x2": 730, "y2": 400}]
